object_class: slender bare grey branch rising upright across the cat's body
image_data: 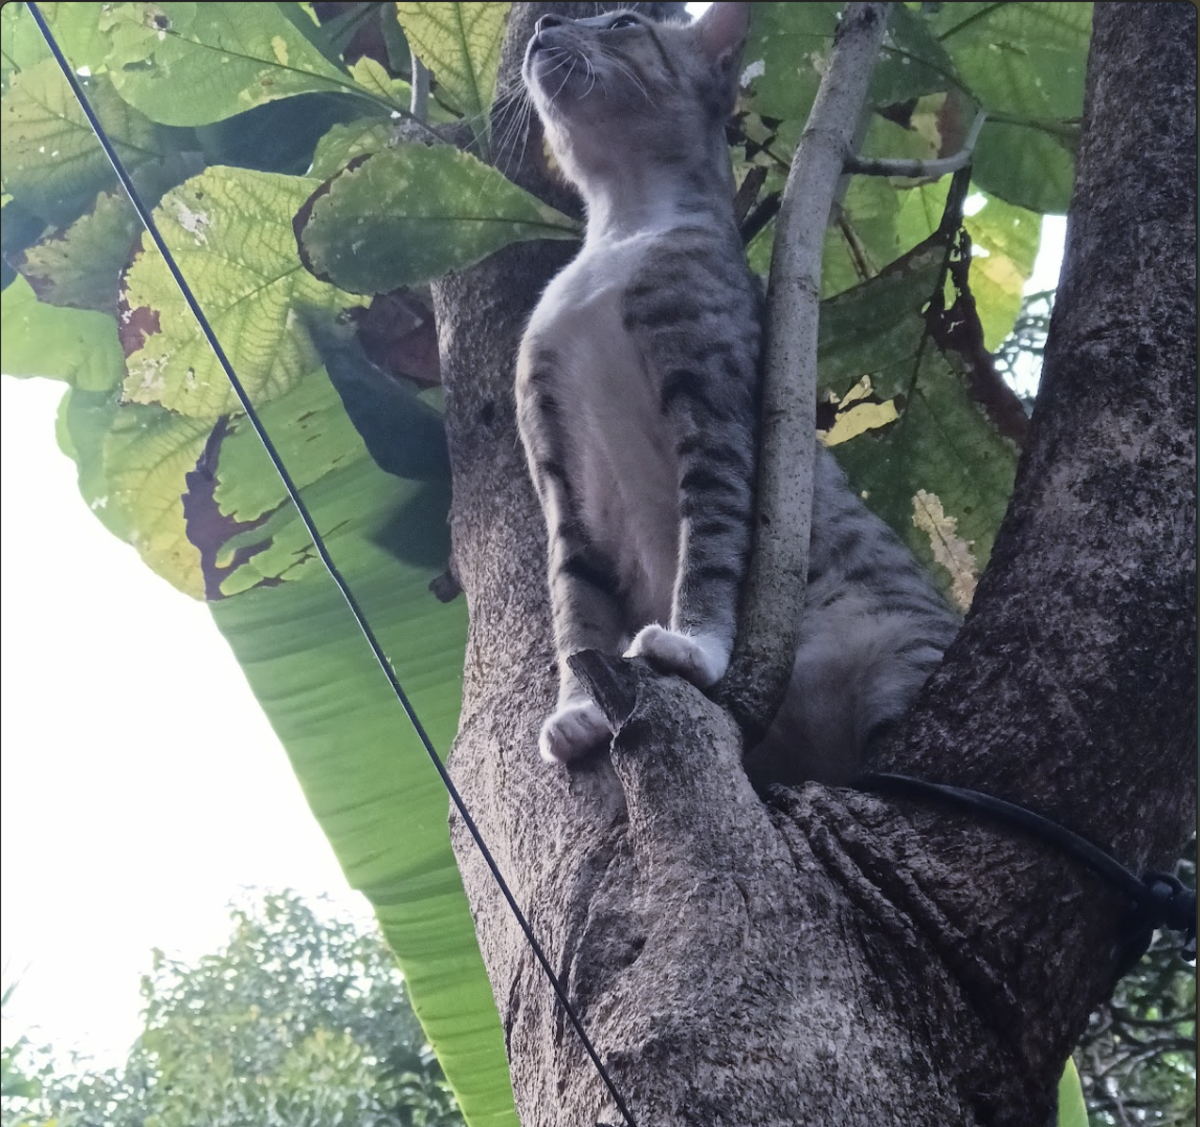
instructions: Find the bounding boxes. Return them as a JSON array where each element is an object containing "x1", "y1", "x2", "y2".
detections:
[{"x1": 721, "y1": 2, "x2": 889, "y2": 743}]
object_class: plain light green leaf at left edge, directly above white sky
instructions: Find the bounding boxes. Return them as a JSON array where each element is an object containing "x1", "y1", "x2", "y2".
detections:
[{"x1": 0, "y1": 278, "x2": 124, "y2": 391}]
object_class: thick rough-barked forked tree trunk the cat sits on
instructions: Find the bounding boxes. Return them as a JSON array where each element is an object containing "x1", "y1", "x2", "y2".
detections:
[{"x1": 434, "y1": 4, "x2": 1196, "y2": 1127}]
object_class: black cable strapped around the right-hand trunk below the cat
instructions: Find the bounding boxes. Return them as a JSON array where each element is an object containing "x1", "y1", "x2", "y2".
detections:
[{"x1": 853, "y1": 774, "x2": 1196, "y2": 978}]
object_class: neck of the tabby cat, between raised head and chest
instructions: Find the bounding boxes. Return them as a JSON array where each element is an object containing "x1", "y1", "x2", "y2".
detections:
[{"x1": 582, "y1": 156, "x2": 733, "y2": 247}]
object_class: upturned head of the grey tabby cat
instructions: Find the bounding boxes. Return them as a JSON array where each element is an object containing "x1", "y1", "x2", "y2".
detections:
[{"x1": 522, "y1": 4, "x2": 750, "y2": 186}]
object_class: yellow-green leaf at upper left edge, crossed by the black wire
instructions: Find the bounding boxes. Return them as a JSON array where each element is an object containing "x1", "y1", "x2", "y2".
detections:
[{"x1": 0, "y1": 59, "x2": 164, "y2": 226}]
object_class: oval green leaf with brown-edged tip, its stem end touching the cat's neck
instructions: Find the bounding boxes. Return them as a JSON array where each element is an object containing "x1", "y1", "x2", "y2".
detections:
[{"x1": 300, "y1": 145, "x2": 578, "y2": 294}]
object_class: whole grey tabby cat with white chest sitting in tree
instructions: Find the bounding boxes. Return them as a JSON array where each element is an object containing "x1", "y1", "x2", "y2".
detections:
[{"x1": 516, "y1": 4, "x2": 958, "y2": 783}]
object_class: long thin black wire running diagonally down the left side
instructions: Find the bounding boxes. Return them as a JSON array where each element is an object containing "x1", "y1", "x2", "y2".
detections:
[{"x1": 28, "y1": 0, "x2": 637, "y2": 1127}]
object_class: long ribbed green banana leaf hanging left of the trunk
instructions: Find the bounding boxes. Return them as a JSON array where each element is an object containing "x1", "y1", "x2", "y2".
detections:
[{"x1": 212, "y1": 417, "x2": 516, "y2": 1127}]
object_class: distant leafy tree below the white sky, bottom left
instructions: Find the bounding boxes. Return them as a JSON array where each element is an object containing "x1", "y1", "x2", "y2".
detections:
[{"x1": 4, "y1": 893, "x2": 462, "y2": 1127}]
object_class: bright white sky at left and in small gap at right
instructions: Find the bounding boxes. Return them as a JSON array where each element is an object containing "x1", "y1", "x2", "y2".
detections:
[{"x1": 0, "y1": 160, "x2": 1066, "y2": 1084}]
